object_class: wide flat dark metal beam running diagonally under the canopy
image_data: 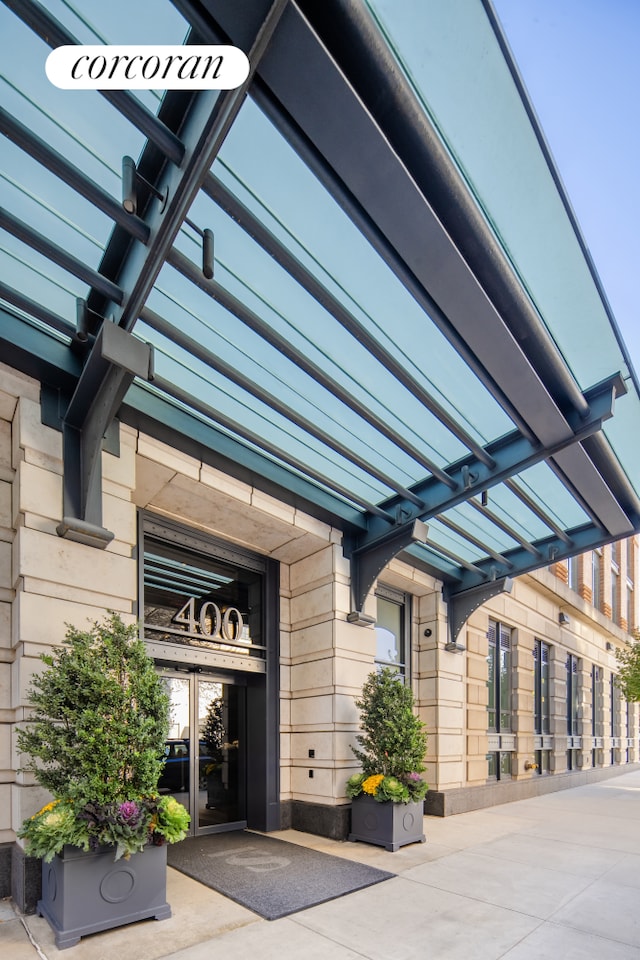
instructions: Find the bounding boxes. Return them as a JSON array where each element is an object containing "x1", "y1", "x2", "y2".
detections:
[{"x1": 224, "y1": 5, "x2": 625, "y2": 552}]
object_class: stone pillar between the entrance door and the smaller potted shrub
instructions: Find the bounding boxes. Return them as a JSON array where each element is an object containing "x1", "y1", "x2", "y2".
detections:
[{"x1": 283, "y1": 543, "x2": 376, "y2": 839}]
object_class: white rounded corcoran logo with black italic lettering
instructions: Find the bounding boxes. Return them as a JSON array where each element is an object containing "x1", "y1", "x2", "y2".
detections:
[{"x1": 46, "y1": 45, "x2": 249, "y2": 90}]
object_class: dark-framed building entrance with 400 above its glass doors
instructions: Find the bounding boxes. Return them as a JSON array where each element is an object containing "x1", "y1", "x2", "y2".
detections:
[{"x1": 139, "y1": 514, "x2": 280, "y2": 833}]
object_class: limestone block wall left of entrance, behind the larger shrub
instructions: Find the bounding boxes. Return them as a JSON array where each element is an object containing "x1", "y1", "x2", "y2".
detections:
[{"x1": 7, "y1": 374, "x2": 137, "y2": 839}]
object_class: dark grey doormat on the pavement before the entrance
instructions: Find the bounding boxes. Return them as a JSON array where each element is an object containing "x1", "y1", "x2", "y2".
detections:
[{"x1": 167, "y1": 830, "x2": 395, "y2": 920}]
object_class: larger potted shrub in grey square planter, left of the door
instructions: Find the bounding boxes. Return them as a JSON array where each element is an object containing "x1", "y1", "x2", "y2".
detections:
[{"x1": 18, "y1": 614, "x2": 189, "y2": 948}]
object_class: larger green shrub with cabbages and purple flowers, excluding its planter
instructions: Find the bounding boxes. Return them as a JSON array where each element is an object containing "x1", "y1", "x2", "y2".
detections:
[{"x1": 18, "y1": 614, "x2": 190, "y2": 861}]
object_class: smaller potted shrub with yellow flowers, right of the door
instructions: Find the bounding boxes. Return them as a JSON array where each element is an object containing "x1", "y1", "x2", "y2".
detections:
[{"x1": 347, "y1": 667, "x2": 428, "y2": 851}]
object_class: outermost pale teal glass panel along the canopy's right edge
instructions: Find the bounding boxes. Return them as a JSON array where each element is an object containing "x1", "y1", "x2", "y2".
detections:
[{"x1": 366, "y1": 0, "x2": 640, "y2": 492}]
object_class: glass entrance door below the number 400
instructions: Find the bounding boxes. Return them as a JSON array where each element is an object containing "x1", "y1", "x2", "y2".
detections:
[{"x1": 159, "y1": 670, "x2": 247, "y2": 834}]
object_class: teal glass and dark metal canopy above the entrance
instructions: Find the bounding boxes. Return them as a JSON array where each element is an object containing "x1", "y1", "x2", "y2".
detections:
[{"x1": 0, "y1": 0, "x2": 640, "y2": 612}]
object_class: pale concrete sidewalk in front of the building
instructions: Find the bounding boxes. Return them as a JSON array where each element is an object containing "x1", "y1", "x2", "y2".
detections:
[{"x1": 5, "y1": 771, "x2": 640, "y2": 960}]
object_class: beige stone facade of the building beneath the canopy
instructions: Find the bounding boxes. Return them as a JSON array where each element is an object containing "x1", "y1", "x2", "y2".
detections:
[{"x1": 0, "y1": 365, "x2": 639, "y2": 908}]
